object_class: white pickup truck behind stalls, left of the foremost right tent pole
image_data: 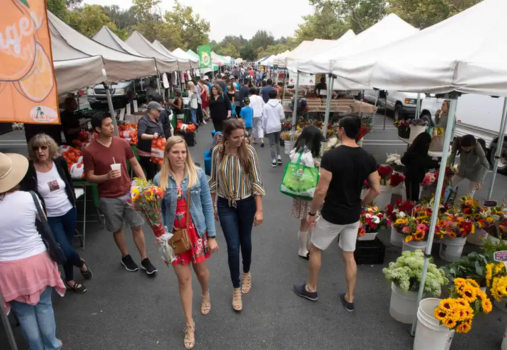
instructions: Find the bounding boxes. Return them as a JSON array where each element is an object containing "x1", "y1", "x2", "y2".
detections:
[{"x1": 364, "y1": 90, "x2": 425, "y2": 120}]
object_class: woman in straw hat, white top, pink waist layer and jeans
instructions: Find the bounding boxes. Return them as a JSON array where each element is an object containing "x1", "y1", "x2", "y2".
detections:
[{"x1": 0, "y1": 153, "x2": 65, "y2": 350}]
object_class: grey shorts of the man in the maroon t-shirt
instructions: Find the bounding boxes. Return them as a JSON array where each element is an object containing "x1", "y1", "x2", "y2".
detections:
[{"x1": 100, "y1": 193, "x2": 144, "y2": 232}]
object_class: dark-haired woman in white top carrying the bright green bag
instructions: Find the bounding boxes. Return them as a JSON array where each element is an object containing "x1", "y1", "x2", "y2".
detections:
[{"x1": 290, "y1": 125, "x2": 325, "y2": 260}]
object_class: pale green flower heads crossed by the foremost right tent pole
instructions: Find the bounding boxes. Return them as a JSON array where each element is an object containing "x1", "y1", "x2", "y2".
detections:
[{"x1": 382, "y1": 250, "x2": 449, "y2": 297}]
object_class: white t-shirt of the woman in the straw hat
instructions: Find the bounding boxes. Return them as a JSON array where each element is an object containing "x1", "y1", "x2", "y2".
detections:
[{"x1": 0, "y1": 191, "x2": 46, "y2": 261}]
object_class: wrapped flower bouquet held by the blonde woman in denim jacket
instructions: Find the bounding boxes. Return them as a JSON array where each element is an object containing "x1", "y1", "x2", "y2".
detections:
[{"x1": 128, "y1": 178, "x2": 176, "y2": 264}]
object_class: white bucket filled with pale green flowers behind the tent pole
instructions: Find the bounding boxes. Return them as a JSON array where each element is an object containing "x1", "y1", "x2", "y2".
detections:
[{"x1": 382, "y1": 250, "x2": 449, "y2": 323}]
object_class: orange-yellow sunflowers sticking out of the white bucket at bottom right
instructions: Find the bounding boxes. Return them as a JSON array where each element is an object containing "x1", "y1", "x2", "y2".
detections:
[{"x1": 435, "y1": 278, "x2": 493, "y2": 333}]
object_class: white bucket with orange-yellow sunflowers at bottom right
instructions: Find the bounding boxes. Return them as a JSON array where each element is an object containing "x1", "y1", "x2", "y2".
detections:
[{"x1": 414, "y1": 278, "x2": 492, "y2": 350}]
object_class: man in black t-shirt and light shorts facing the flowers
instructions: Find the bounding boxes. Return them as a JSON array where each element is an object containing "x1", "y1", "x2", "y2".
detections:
[{"x1": 294, "y1": 117, "x2": 380, "y2": 312}]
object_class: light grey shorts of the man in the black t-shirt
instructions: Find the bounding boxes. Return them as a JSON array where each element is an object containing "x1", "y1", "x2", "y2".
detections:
[{"x1": 312, "y1": 216, "x2": 359, "y2": 252}]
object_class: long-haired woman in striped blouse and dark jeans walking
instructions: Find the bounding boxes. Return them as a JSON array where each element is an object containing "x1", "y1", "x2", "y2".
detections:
[{"x1": 209, "y1": 119, "x2": 265, "y2": 311}]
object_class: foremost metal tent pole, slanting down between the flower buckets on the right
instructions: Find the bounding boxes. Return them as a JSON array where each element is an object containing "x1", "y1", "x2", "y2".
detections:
[{"x1": 410, "y1": 93, "x2": 458, "y2": 336}]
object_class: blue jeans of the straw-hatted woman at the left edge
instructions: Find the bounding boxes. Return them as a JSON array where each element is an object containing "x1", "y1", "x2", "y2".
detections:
[{"x1": 11, "y1": 287, "x2": 61, "y2": 350}]
